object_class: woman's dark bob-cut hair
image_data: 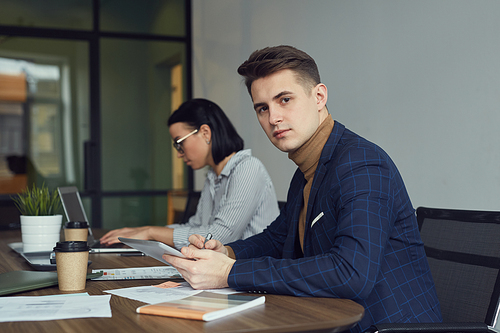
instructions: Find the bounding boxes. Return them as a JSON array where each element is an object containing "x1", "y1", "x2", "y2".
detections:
[{"x1": 167, "y1": 98, "x2": 244, "y2": 164}]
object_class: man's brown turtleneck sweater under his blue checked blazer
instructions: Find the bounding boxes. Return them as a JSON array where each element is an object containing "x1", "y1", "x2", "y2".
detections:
[{"x1": 288, "y1": 115, "x2": 334, "y2": 250}]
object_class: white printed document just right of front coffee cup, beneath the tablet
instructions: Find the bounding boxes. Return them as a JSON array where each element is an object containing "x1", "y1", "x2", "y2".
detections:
[{"x1": 92, "y1": 266, "x2": 182, "y2": 280}]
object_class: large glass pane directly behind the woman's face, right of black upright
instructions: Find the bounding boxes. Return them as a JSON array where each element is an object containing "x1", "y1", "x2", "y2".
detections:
[{"x1": 101, "y1": 39, "x2": 185, "y2": 191}]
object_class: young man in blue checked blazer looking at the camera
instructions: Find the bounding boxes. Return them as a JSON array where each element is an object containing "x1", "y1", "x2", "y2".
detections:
[{"x1": 166, "y1": 46, "x2": 441, "y2": 332}]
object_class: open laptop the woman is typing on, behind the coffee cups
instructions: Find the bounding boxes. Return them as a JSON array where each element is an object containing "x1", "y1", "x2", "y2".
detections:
[{"x1": 57, "y1": 186, "x2": 140, "y2": 253}]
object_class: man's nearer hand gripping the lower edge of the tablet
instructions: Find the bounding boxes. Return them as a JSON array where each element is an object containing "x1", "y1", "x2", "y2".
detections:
[{"x1": 163, "y1": 243, "x2": 235, "y2": 289}]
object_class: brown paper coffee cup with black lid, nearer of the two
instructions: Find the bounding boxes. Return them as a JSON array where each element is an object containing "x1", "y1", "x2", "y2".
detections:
[{"x1": 54, "y1": 241, "x2": 89, "y2": 291}]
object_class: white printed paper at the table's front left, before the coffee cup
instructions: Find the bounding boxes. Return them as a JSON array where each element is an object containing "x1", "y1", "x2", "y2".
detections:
[{"x1": 0, "y1": 295, "x2": 111, "y2": 322}]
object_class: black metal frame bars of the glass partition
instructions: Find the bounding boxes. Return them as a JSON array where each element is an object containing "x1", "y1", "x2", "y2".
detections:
[{"x1": 0, "y1": 0, "x2": 194, "y2": 228}]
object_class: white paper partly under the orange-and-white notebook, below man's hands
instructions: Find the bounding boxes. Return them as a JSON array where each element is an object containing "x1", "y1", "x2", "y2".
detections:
[{"x1": 104, "y1": 282, "x2": 237, "y2": 304}]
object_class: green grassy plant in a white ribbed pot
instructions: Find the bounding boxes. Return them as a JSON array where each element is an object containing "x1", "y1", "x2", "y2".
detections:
[{"x1": 12, "y1": 184, "x2": 62, "y2": 252}]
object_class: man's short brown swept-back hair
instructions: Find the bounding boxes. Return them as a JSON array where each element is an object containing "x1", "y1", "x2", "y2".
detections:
[{"x1": 238, "y1": 45, "x2": 321, "y2": 96}]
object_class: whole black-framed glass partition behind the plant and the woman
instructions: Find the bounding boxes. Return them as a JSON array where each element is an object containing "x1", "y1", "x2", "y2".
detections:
[{"x1": 0, "y1": 0, "x2": 192, "y2": 229}]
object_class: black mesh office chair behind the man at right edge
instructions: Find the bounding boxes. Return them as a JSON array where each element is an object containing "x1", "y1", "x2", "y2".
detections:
[{"x1": 366, "y1": 207, "x2": 500, "y2": 333}]
